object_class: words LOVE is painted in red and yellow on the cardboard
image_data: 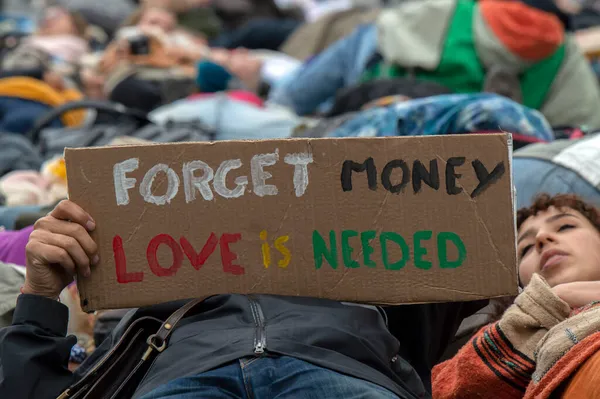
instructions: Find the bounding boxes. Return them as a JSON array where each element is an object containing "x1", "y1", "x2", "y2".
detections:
[{"x1": 113, "y1": 230, "x2": 292, "y2": 284}]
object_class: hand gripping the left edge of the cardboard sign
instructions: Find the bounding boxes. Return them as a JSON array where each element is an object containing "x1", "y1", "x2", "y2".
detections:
[{"x1": 23, "y1": 201, "x2": 100, "y2": 299}]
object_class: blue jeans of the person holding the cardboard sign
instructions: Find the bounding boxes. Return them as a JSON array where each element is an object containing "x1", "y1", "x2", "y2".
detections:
[{"x1": 141, "y1": 356, "x2": 398, "y2": 399}]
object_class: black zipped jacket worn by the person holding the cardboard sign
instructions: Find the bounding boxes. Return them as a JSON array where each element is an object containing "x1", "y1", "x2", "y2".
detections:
[{"x1": 0, "y1": 295, "x2": 482, "y2": 399}]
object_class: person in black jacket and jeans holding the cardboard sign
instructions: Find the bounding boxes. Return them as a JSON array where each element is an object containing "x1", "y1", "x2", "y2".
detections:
[{"x1": 0, "y1": 201, "x2": 487, "y2": 399}]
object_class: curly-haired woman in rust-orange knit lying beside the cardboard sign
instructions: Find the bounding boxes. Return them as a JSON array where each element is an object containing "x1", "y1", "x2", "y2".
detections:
[{"x1": 432, "y1": 194, "x2": 600, "y2": 399}]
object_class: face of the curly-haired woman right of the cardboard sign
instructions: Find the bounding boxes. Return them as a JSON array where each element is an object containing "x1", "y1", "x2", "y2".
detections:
[{"x1": 517, "y1": 207, "x2": 600, "y2": 287}]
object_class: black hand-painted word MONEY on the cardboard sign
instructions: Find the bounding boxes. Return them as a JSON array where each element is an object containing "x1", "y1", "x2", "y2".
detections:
[{"x1": 341, "y1": 157, "x2": 505, "y2": 198}]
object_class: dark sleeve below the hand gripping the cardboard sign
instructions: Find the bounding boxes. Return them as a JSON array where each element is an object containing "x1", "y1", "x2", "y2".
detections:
[{"x1": 0, "y1": 295, "x2": 76, "y2": 399}]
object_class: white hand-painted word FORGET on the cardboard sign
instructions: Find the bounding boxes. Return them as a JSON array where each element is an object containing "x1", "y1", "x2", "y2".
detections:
[{"x1": 113, "y1": 149, "x2": 313, "y2": 206}]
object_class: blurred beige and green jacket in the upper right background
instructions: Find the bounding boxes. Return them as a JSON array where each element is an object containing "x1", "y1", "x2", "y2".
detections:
[{"x1": 364, "y1": 0, "x2": 600, "y2": 128}]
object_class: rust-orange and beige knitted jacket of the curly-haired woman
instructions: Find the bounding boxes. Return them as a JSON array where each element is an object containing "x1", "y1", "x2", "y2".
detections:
[{"x1": 432, "y1": 275, "x2": 600, "y2": 399}]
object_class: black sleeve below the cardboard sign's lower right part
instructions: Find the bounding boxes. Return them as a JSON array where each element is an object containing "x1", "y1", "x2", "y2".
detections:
[{"x1": 386, "y1": 300, "x2": 489, "y2": 392}]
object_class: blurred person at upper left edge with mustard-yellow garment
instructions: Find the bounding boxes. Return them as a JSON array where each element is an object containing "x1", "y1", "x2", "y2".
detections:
[{"x1": 0, "y1": 7, "x2": 89, "y2": 134}]
